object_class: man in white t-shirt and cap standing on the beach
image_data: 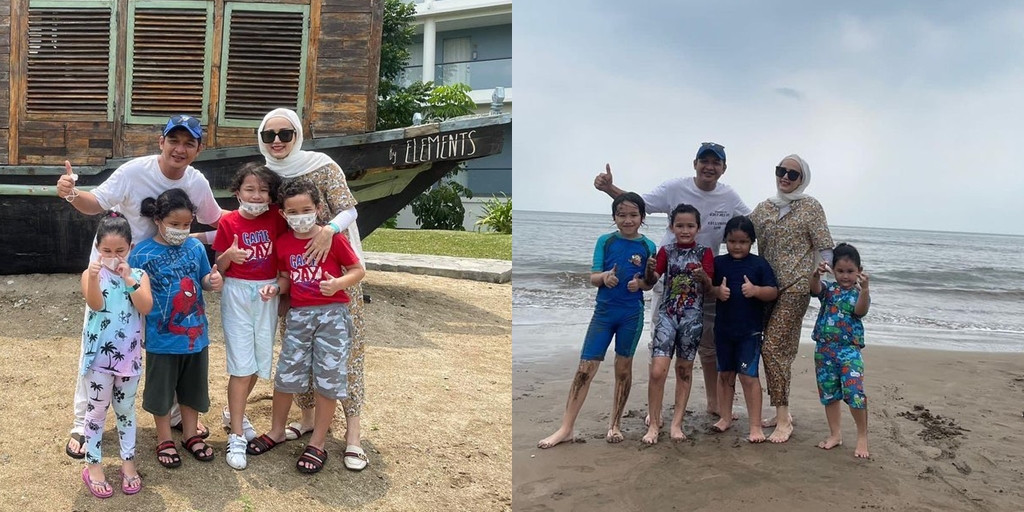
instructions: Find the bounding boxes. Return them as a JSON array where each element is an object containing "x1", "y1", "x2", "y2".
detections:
[{"x1": 594, "y1": 142, "x2": 751, "y2": 414}]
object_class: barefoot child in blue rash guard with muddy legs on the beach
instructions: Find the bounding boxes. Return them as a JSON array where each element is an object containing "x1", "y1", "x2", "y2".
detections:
[{"x1": 537, "y1": 193, "x2": 655, "y2": 449}]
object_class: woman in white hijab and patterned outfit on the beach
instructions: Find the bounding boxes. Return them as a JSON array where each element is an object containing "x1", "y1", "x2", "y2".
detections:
[{"x1": 750, "y1": 155, "x2": 835, "y2": 442}]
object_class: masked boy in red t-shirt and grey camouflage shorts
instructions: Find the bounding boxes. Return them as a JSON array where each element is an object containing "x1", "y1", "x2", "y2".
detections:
[{"x1": 247, "y1": 180, "x2": 366, "y2": 473}]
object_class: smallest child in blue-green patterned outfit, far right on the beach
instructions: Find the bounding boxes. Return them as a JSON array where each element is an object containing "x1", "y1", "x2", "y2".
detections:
[{"x1": 810, "y1": 244, "x2": 871, "y2": 459}]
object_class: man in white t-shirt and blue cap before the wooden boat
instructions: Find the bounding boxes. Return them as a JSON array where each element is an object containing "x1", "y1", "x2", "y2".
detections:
[{"x1": 57, "y1": 116, "x2": 221, "y2": 459}]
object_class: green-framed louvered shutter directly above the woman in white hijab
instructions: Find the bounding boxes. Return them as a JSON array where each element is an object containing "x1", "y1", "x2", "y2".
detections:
[{"x1": 220, "y1": 3, "x2": 309, "y2": 126}]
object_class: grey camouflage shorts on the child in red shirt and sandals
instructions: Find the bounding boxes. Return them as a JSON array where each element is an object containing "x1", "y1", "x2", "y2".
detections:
[{"x1": 273, "y1": 303, "x2": 352, "y2": 400}]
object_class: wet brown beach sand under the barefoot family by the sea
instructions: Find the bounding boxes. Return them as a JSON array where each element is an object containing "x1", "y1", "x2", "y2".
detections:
[{"x1": 512, "y1": 326, "x2": 1024, "y2": 512}]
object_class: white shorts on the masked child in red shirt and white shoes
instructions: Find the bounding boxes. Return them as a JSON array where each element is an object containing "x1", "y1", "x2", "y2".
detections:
[{"x1": 220, "y1": 278, "x2": 280, "y2": 379}]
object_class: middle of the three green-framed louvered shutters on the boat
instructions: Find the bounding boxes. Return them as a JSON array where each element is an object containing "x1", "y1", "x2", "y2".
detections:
[{"x1": 126, "y1": 1, "x2": 213, "y2": 123}]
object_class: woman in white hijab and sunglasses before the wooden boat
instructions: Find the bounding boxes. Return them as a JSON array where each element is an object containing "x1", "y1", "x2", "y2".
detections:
[{"x1": 257, "y1": 109, "x2": 368, "y2": 471}]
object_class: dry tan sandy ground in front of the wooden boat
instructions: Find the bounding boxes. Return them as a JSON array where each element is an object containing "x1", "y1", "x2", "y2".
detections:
[{"x1": 0, "y1": 272, "x2": 512, "y2": 511}]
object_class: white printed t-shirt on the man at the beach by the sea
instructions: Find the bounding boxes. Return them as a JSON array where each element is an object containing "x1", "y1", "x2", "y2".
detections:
[{"x1": 640, "y1": 177, "x2": 751, "y2": 255}]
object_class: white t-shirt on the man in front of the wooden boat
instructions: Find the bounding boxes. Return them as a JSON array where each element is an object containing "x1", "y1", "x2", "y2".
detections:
[{"x1": 91, "y1": 155, "x2": 220, "y2": 241}]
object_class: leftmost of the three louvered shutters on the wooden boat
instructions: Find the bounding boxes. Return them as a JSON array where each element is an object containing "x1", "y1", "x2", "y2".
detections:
[{"x1": 26, "y1": 0, "x2": 115, "y2": 119}]
